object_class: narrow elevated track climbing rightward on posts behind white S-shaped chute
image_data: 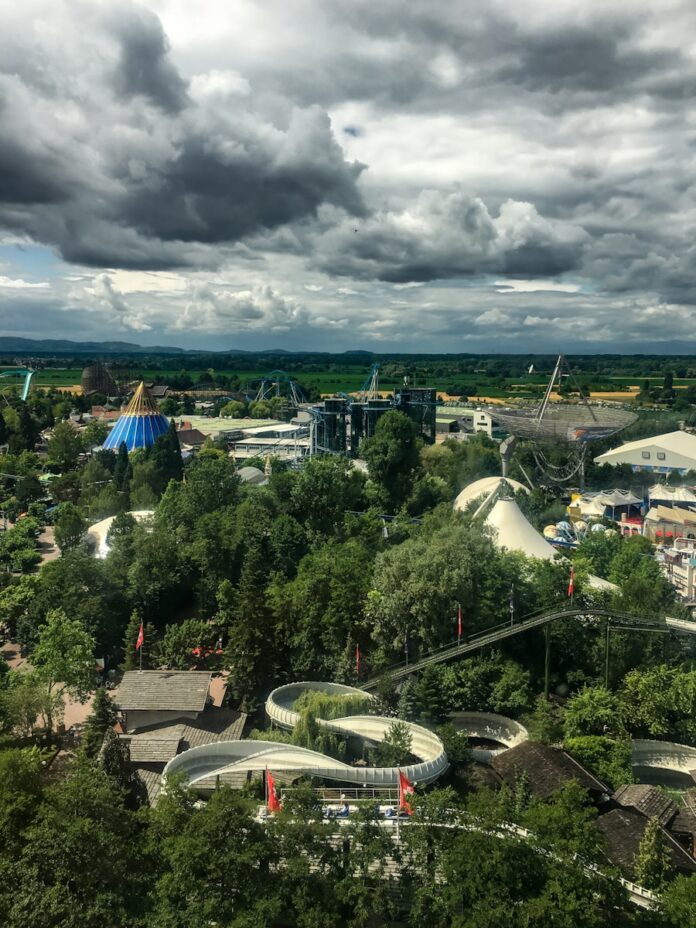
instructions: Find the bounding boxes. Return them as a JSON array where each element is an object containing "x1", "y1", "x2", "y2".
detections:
[{"x1": 360, "y1": 607, "x2": 696, "y2": 691}]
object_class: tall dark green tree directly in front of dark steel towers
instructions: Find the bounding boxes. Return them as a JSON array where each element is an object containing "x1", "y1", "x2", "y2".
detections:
[{"x1": 360, "y1": 410, "x2": 422, "y2": 512}]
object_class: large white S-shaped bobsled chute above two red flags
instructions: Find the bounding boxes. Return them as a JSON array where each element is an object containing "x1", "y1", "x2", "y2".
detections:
[{"x1": 164, "y1": 681, "x2": 449, "y2": 786}]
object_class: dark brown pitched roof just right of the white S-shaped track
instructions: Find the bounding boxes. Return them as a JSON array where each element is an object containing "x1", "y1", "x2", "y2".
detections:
[{"x1": 491, "y1": 741, "x2": 610, "y2": 799}]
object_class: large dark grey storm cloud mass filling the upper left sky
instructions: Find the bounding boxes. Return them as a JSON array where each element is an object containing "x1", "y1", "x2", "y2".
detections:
[{"x1": 0, "y1": 3, "x2": 364, "y2": 268}]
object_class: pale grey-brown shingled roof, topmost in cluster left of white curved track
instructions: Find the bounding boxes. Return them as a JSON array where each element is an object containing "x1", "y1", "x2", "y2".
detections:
[{"x1": 114, "y1": 670, "x2": 212, "y2": 712}]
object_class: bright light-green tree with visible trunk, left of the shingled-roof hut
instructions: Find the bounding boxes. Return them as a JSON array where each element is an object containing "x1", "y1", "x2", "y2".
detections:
[{"x1": 32, "y1": 609, "x2": 95, "y2": 732}]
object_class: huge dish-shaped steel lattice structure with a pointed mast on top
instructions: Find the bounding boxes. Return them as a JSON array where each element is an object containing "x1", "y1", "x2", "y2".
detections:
[{"x1": 486, "y1": 354, "x2": 637, "y2": 484}]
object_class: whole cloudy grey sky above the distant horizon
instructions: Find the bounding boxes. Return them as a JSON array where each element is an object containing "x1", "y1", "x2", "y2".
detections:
[{"x1": 0, "y1": 0, "x2": 696, "y2": 353}]
